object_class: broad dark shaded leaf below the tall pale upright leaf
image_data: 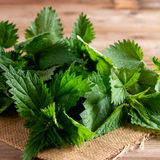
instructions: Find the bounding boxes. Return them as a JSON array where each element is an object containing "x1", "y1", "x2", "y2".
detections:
[{"x1": 16, "y1": 33, "x2": 77, "y2": 70}]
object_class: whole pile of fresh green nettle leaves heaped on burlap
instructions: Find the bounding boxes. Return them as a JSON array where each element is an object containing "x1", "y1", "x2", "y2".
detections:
[{"x1": 0, "y1": 7, "x2": 160, "y2": 160}]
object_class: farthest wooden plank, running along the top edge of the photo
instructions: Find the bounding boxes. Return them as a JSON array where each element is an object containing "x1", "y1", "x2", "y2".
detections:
[{"x1": 0, "y1": 0, "x2": 160, "y2": 9}]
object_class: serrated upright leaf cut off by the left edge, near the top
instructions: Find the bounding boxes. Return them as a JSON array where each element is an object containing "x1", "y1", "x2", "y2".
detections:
[{"x1": 0, "y1": 21, "x2": 19, "y2": 48}]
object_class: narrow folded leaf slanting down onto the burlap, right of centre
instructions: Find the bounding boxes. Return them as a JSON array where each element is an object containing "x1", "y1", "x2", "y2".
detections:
[{"x1": 95, "y1": 103, "x2": 128, "y2": 136}]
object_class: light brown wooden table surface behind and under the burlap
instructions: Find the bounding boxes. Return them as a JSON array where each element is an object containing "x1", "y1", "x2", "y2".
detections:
[{"x1": 0, "y1": 0, "x2": 160, "y2": 160}]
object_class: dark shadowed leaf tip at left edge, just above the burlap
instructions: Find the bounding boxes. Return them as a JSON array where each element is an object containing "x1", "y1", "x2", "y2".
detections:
[{"x1": 0, "y1": 92, "x2": 13, "y2": 114}]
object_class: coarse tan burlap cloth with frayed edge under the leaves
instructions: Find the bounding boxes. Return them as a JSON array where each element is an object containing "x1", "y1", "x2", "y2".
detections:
[{"x1": 0, "y1": 105, "x2": 159, "y2": 160}]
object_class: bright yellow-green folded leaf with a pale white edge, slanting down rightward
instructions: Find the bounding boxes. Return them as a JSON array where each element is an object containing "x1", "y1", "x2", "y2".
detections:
[{"x1": 77, "y1": 36, "x2": 113, "y2": 73}]
